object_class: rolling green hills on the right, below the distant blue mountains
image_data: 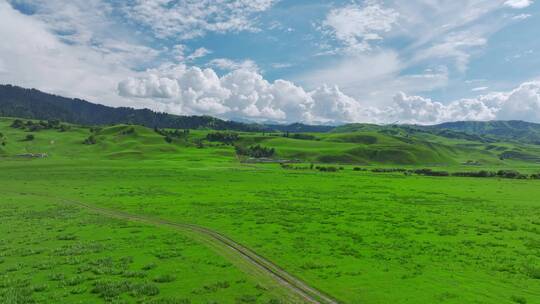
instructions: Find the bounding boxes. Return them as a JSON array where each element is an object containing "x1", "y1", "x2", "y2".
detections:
[{"x1": 240, "y1": 125, "x2": 540, "y2": 165}]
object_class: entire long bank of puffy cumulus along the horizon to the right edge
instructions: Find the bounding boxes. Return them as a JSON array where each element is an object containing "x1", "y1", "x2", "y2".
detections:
[{"x1": 118, "y1": 65, "x2": 540, "y2": 124}]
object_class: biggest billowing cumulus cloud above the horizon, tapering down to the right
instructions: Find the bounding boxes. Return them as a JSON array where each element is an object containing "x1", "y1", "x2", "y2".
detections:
[{"x1": 118, "y1": 65, "x2": 384, "y2": 123}]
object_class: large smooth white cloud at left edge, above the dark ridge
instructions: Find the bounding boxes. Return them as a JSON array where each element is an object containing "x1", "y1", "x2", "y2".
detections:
[{"x1": 0, "y1": 0, "x2": 146, "y2": 106}]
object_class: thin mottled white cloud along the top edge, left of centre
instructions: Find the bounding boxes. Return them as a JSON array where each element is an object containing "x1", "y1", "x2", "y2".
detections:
[{"x1": 118, "y1": 0, "x2": 277, "y2": 39}]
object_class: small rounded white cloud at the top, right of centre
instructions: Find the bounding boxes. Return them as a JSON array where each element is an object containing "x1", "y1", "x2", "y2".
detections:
[{"x1": 323, "y1": 1, "x2": 399, "y2": 50}]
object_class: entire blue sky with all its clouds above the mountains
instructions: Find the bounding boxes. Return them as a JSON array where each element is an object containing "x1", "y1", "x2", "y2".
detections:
[{"x1": 0, "y1": 0, "x2": 540, "y2": 124}]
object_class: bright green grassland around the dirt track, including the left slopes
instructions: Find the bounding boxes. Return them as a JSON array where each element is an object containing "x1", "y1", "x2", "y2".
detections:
[{"x1": 0, "y1": 119, "x2": 540, "y2": 303}]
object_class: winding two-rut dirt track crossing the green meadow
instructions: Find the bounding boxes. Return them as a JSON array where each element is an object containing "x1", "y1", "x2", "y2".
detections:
[{"x1": 64, "y1": 201, "x2": 338, "y2": 304}]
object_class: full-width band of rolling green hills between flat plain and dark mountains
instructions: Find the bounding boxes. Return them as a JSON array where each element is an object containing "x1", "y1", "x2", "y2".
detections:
[{"x1": 4, "y1": 118, "x2": 540, "y2": 166}]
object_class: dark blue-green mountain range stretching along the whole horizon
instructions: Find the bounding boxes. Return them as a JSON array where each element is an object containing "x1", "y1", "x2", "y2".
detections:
[{"x1": 0, "y1": 85, "x2": 540, "y2": 144}]
